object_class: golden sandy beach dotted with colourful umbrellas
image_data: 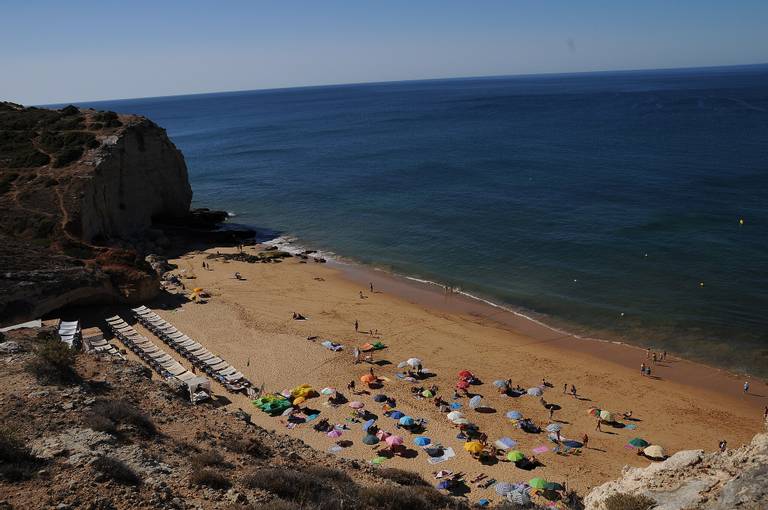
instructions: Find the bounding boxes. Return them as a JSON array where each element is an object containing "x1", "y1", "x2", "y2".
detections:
[{"x1": 120, "y1": 247, "x2": 768, "y2": 499}]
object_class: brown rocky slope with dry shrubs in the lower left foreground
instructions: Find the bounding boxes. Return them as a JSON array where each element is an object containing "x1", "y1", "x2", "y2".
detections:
[{"x1": 0, "y1": 330, "x2": 492, "y2": 510}]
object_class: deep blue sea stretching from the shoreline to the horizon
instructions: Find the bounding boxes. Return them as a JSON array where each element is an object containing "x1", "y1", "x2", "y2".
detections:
[{"x1": 75, "y1": 66, "x2": 768, "y2": 376}]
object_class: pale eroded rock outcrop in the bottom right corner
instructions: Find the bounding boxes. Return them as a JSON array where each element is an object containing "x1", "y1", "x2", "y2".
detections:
[{"x1": 584, "y1": 433, "x2": 768, "y2": 510}]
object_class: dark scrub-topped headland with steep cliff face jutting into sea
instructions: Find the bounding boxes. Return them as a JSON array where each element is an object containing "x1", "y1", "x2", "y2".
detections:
[{"x1": 0, "y1": 103, "x2": 192, "y2": 324}]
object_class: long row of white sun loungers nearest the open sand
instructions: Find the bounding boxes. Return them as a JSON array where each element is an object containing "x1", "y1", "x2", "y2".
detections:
[{"x1": 133, "y1": 306, "x2": 252, "y2": 393}]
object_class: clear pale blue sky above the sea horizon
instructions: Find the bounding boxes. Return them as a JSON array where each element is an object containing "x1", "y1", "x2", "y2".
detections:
[{"x1": 0, "y1": 0, "x2": 768, "y2": 104}]
